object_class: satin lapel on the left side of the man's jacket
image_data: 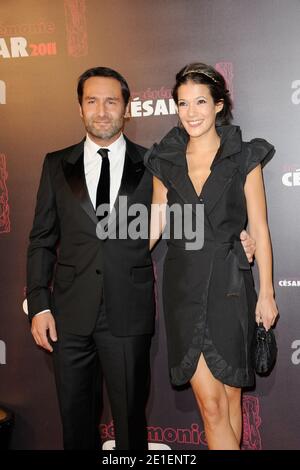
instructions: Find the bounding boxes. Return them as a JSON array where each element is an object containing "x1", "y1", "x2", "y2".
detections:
[{"x1": 63, "y1": 140, "x2": 98, "y2": 224}]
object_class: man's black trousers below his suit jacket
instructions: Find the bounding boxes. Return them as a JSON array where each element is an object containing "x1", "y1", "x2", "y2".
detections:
[{"x1": 53, "y1": 304, "x2": 151, "y2": 450}]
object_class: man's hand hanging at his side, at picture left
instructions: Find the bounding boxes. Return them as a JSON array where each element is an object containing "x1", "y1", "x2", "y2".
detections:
[{"x1": 31, "y1": 310, "x2": 57, "y2": 352}]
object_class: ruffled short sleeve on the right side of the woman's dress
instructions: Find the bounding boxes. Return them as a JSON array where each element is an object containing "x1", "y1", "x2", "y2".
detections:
[{"x1": 243, "y1": 139, "x2": 275, "y2": 175}]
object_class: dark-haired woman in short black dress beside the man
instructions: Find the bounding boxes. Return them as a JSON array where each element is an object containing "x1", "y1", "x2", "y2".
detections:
[{"x1": 146, "y1": 63, "x2": 277, "y2": 449}]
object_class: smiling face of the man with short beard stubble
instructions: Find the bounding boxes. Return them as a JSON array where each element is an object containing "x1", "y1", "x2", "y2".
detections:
[{"x1": 80, "y1": 77, "x2": 128, "y2": 147}]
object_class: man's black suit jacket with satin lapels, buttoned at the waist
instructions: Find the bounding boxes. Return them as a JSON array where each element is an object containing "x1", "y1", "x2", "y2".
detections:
[{"x1": 27, "y1": 134, "x2": 154, "y2": 336}]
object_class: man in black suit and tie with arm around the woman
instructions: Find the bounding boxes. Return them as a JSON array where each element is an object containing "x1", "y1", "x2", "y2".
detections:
[{"x1": 27, "y1": 67, "x2": 254, "y2": 449}]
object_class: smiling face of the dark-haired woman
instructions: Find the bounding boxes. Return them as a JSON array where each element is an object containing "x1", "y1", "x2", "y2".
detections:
[{"x1": 178, "y1": 81, "x2": 223, "y2": 138}]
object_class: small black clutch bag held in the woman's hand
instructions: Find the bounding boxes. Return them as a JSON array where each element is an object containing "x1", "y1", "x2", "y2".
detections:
[{"x1": 253, "y1": 323, "x2": 277, "y2": 374}]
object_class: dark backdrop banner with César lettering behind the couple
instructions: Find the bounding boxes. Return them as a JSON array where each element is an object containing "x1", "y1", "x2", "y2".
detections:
[{"x1": 0, "y1": 0, "x2": 300, "y2": 450}]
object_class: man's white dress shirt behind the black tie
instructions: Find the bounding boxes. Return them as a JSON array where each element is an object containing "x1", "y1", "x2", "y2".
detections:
[{"x1": 84, "y1": 134, "x2": 126, "y2": 210}]
